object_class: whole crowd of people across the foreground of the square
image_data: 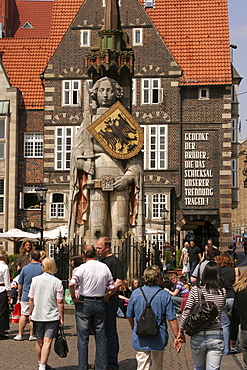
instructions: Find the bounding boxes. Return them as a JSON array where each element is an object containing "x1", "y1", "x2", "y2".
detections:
[{"x1": 0, "y1": 237, "x2": 247, "y2": 370}]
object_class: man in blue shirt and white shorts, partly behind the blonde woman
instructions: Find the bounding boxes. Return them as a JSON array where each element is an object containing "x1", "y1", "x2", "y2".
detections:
[{"x1": 14, "y1": 249, "x2": 42, "y2": 341}]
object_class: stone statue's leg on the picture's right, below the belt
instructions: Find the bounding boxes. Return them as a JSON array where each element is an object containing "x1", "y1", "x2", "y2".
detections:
[{"x1": 110, "y1": 189, "x2": 129, "y2": 239}]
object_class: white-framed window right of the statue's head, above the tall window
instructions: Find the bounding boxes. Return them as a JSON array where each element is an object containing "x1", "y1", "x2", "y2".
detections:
[{"x1": 142, "y1": 78, "x2": 163, "y2": 105}]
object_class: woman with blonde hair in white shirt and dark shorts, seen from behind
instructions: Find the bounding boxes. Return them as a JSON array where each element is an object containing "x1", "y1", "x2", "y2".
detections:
[{"x1": 29, "y1": 257, "x2": 64, "y2": 370}]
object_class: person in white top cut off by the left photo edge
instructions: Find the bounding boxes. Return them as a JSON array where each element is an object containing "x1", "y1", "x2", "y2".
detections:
[{"x1": 0, "y1": 250, "x2": 10, "y2": 339}]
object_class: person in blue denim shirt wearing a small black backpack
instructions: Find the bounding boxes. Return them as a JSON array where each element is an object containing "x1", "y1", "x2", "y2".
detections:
[{"x1": 126, "y1": 266, "x2": 183, "y2": 370}]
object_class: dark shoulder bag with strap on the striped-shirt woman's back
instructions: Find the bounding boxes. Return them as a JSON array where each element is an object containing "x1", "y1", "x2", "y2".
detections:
[{"x1": 185, "y1": 266, "x2": 218, "y2": 337}]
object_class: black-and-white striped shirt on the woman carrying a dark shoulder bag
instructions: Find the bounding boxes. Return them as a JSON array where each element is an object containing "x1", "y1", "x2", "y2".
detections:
[{"x1": 179, "y1": 286, "x2": 226, "y2": 330}]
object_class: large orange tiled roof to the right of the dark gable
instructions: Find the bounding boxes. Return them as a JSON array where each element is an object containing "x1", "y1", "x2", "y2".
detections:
[{"x1": 144, "y1": 0, "x2": 231, "y2": 85}]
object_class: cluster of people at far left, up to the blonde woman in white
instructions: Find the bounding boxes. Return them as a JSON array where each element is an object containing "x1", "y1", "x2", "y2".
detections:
[{"x1": 0, "y1": 241, "x2": 64, "y2": 370}]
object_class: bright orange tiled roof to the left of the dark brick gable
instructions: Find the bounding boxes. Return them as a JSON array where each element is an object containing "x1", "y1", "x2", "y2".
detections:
[{"x1": 0, "y1": 0, "x2": 83, "y2": 109}]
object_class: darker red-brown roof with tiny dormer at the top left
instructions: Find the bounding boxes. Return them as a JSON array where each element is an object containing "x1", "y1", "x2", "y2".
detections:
[{"x1": 11, "y1": 0, "x2": 53, "y2": 38}]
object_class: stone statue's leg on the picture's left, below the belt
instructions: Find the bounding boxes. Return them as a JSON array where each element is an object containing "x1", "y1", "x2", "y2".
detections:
[{"x1": 89, "y1": 189, "x2": 108, "y2": 240}]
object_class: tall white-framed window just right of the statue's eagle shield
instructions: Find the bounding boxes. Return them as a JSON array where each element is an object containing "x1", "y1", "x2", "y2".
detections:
[{"x1": 148, "y1": 125, "x2": 167, "y2": 170}]
